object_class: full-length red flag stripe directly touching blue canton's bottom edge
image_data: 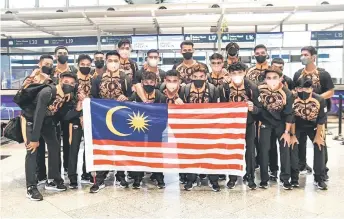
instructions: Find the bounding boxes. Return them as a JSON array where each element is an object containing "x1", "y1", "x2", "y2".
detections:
[{"x1": 93, "y1": 139, "x2": 244, "y2": 150}]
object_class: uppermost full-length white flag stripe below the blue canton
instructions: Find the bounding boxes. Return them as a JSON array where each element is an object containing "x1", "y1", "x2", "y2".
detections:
[{"x1": 93, "y1": 144, "x2": 245, "y2": 155}]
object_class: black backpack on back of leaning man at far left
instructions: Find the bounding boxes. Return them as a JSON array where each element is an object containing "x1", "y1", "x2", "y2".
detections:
[{"x1": 13, "y1": 84, "x2": 56, "y2": 109}]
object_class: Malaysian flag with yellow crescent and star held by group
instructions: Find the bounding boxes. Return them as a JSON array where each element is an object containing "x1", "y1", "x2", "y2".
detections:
[{"x1": 83, "y1": 99, "x2": 247, "y2": 176}]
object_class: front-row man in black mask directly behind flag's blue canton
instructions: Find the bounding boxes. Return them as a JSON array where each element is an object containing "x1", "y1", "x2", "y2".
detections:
[{"x1": 129, "y1": 71, "x2": 166, "y2": 189}]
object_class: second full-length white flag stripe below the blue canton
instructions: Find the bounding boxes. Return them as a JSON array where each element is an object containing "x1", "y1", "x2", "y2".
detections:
[{"x1": 94, "y1": 154, "x2": 244, "y2": 165}]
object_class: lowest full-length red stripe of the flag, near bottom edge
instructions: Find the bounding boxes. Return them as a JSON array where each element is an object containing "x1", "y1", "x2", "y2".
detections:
[{"x1": 93, "y1": 160, "x2": 243, "y2": 170}]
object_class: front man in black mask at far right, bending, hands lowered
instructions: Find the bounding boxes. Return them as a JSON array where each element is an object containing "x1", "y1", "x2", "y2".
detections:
[{"x1": 291, "y1": 78, "x2": 327, "y2": 190}]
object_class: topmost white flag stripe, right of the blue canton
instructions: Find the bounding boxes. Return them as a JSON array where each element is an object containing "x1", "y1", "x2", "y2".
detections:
[{"x1": 168, "y1": 107, "x2": 248, "y2": 116}]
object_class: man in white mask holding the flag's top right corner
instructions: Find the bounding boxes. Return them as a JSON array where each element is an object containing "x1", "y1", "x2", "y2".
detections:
[{"x1": 219, "y1": 62, "x2": 262, "y2": 189}]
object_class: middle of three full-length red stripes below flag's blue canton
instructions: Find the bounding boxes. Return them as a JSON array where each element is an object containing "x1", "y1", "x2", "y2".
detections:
[{"x1": 93, "y1": 149, "x2": 243, "y2": 160}]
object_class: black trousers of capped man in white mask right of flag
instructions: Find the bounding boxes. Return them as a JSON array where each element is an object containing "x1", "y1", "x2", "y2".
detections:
[{"x1": 259, "y1": 122, "x2": 291, "y2": 182}]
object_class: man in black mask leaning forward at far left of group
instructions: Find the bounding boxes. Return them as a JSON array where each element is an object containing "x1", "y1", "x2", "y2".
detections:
[{"x1": 21, "y1": 73, "x2": 76, "y2": 201}]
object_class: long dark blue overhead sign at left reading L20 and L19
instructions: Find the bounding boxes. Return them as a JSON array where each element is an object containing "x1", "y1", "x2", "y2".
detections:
[{"x1": 8, "y1": 36, "x2": 97, "y2": 47}]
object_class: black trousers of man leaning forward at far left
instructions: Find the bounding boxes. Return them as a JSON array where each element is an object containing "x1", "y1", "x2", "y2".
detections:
[{"x1": 21, "y1": 117, "x2": 63, "y2": 187}]
